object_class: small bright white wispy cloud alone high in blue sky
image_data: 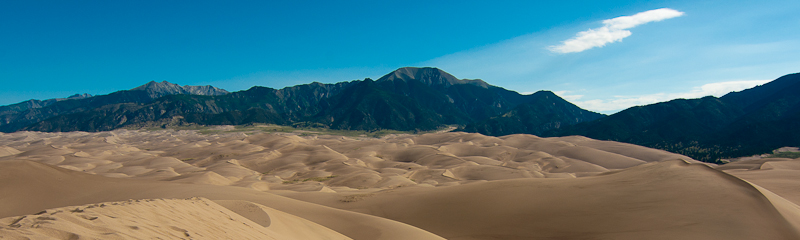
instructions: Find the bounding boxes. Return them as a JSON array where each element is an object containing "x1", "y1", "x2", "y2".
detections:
[{"x1": 547, "y1": 8, "x2": 684, "y2": 53}]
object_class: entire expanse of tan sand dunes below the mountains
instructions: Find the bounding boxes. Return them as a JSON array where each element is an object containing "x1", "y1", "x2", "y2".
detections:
[{"x1": 0, "y1": 129, "x2": 800, "y2": 239}]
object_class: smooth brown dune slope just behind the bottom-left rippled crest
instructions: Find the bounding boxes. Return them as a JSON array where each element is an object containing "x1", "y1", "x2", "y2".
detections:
[{"x1": 0, "y1": 160, "x2": 442, "y2": 240}]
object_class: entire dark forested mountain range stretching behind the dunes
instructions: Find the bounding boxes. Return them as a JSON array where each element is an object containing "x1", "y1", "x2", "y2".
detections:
[{"x1": 0, "y1": 67, "x2": 800, "y2": 162}]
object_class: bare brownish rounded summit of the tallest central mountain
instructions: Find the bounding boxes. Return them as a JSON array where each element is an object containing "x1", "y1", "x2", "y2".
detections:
[{"x1": 378, "y1": 67, "x2": 489, "y2": 88}]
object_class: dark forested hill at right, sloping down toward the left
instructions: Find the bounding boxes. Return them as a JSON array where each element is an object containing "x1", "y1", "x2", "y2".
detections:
[{"x1": 543, "y1": 73, "x2": 800, "y2": 162}]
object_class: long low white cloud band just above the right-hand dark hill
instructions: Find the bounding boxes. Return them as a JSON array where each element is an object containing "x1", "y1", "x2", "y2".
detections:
[{"x1": 560, "y1": 80, "x2": 770, "y2": 113}]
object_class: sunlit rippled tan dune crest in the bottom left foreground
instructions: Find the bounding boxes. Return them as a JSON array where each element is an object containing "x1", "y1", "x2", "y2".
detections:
[{"x1": 0, "y1": 198, "x2": 351, "y2": 240}]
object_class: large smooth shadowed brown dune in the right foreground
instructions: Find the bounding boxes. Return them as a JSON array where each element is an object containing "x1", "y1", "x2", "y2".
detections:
[{"x1": 282, "y1": 161, "x2": 800, "y2": 239}]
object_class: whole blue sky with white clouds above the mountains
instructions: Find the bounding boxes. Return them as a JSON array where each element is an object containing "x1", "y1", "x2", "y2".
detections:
[{"x1": 0, "y1": 0, "x2": 800, "y2": 113}]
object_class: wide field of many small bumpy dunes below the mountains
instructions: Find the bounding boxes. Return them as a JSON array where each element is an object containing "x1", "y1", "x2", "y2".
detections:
[{"x1": 0, "y1": 130, "x2": 693, "y2": 192}]
